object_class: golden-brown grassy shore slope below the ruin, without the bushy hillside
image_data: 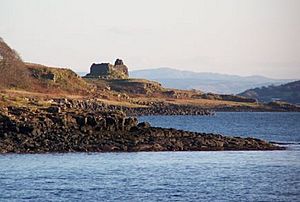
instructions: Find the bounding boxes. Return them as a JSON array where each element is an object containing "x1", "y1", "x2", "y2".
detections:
[{"x1": 0, "y1": 75, "x2": 299, "y2": 111}]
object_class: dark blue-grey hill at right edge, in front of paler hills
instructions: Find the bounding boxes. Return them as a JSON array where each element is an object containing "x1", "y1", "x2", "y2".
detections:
[{"x1": 239, "y1": 80, "x2": 300, "y2": 104}]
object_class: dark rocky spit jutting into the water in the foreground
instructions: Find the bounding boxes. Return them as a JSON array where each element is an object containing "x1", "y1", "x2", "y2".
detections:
[{"x1": 0, "y1": 106, "x2": 282, "y2": 153}]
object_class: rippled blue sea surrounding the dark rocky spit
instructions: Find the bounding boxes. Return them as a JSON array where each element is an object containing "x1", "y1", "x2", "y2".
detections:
[{"x1": 0, "y1": 113, "x2": 300, "y2": 202}]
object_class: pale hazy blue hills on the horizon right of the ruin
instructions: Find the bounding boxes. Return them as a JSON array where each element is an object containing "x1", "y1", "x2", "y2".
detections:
[{"x1": 129, "y1": 68, "x2": 293, "y2": 94}]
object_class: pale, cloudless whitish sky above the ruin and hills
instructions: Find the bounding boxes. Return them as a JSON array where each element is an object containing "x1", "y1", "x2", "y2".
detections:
[{"x1": 0, "y1": 0, "x2": 300, "y2": 79}]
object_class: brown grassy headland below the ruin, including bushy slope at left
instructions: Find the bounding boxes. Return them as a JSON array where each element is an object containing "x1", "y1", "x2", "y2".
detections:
[{"x1": 0, "y1": 39, "x2": 299, "y2": 114}]
